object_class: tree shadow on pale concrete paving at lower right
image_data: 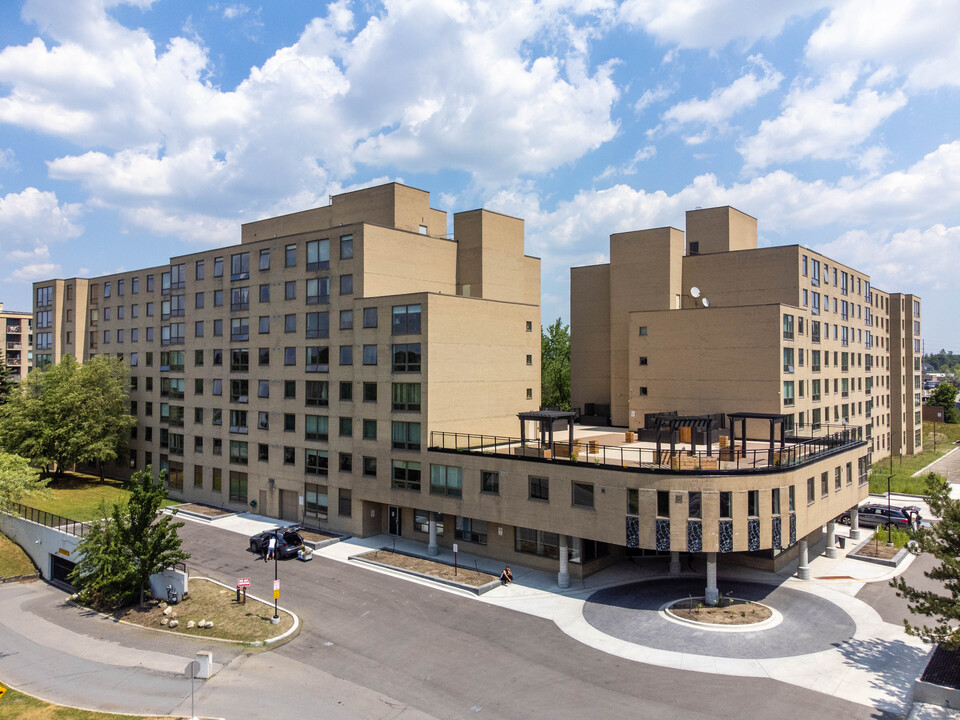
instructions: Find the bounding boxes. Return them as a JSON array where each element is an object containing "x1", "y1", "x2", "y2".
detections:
[{"x1": 837, "y1": 638, "x2": 933, "y2": 704}]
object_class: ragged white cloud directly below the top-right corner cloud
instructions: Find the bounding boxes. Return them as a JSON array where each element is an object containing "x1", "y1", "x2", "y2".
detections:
[{"x1": 737, "y1": 67, "x2": 907, "y2": 168}]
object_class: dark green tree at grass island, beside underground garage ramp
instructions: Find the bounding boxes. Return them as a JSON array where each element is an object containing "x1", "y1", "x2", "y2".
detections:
[{"x1": 69, "y1": 466, "x2": 190, "y2": 608}]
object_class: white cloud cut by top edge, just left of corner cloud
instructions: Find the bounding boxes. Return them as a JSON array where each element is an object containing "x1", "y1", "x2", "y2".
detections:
[{"x1": 620, "y1": 0, "x2": 829, "y2": 49}]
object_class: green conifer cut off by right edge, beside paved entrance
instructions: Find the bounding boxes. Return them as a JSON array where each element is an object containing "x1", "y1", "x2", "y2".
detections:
[{"x1": 890, "y1": 473, "x2": 960, "y2": 650}]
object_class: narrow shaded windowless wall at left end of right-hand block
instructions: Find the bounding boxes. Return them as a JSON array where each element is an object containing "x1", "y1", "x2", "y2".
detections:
[{"x1": 570, "y1": 264, "x2": 610, "y2": 410}]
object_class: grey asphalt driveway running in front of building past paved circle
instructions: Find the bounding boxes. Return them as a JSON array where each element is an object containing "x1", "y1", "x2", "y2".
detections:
[{"x1": 181, "y1": 523, "x2": 895, "y2": 720}]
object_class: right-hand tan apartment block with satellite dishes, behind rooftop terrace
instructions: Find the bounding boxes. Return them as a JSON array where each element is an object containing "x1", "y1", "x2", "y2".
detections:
[{"x1": 571, "y1": 207, "x2": 922, "y2": 460}]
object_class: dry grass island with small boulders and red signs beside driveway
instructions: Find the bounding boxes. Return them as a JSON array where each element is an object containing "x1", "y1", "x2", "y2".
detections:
[{"x1": 117, "y1": 580, "x2": 293, "y2": 642}]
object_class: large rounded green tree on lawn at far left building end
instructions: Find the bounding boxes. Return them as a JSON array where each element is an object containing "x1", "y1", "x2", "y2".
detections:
[{"x1": 0, "y1": 355, "x2": 136, "y2": 474}]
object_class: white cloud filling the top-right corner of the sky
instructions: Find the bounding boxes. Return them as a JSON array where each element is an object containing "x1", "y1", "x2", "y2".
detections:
[{"x1": 806, "y1": 0, "x2": 960, "y2": 89}]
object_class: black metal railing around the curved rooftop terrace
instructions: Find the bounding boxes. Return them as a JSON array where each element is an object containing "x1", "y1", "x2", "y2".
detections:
[{"x1": 428, "y1": 426, "x2": 863, "y2": 474}]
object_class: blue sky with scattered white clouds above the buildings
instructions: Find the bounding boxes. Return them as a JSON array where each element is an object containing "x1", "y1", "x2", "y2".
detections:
[{"x1": 0, "y1": 0, "x2": 960, "y2": 352}]
